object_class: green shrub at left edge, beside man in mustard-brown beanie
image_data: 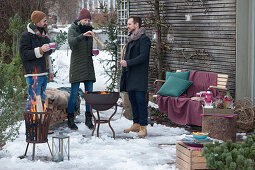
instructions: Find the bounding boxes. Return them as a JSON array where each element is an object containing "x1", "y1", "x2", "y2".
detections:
[{"x1": 0, "y1": 57, "x2": 26, "y2": 149}]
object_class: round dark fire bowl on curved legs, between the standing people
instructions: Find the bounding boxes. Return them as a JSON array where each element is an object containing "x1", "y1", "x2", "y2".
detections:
[{"x1": 84, "y1": 91, "x2": 119, "y2": 139}]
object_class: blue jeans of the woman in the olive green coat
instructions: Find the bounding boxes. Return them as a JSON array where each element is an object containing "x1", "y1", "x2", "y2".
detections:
[{"x1": 67, "y1": 81, "x2": 93, "y2": 115}]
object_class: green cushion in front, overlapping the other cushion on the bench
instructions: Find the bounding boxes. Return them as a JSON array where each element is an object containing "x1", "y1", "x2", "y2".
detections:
[{"x1": 157, "y1": 76, "x2": 192, "y2": 97}]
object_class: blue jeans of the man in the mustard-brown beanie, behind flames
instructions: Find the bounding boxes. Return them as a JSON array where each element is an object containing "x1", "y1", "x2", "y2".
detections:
[{"x1": 26, "y1": 75, "x2": 48, "y2": 110}]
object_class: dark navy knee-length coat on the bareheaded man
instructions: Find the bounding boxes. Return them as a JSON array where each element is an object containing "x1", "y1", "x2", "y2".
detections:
[{"x1": 120, "y1": 34, "x2": 151, "y2": 91}]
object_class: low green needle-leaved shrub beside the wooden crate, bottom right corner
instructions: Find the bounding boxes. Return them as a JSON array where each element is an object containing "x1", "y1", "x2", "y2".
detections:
[{"x1": 203, "y1": 135, "x2": 255, "y2": 170}]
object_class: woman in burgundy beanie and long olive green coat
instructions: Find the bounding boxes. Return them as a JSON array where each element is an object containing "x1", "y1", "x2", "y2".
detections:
[{"x1": 67, "y1": 8, "x2": 96, "y2": 130}]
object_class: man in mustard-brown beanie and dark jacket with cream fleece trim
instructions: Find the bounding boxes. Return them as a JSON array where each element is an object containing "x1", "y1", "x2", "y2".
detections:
[{"x1": 20, "y1": 11, "x2": 54, "y2": 110}]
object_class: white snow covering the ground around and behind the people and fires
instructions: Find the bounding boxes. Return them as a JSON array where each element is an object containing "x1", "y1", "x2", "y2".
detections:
[{"x1": 0, "y1": 40, "x2": 189, "y2": 170}]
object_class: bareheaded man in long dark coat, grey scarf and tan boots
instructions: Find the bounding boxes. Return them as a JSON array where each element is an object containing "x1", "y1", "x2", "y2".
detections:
[{"x1": 120, "y1": 17, "x2": 151, "y2": 137}]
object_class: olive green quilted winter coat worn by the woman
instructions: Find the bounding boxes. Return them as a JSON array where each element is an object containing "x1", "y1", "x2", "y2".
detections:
[{"x1": 68, "y1": 23, "x2": 96, "y2": 83}]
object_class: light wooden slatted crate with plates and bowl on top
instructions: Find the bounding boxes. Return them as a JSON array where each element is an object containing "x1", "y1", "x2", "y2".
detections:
[{"x1": 175, "y1": 142, "x2": 207, "y2": 170}]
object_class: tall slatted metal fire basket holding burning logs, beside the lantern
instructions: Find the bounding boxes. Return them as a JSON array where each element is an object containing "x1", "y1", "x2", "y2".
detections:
[{"x1": 24, "y1": 111, "x2": 52, "y2": 160}]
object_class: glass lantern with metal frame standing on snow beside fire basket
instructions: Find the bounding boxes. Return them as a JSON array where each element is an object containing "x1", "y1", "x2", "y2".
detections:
[{"x1": 52, "y1": 132, "x2": 70, "y2": 162}]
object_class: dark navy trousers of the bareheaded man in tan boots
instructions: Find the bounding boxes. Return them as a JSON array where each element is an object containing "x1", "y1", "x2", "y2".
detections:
[{"x1": 128, "y1": 91, "x2": 148, "y2": 126}]
